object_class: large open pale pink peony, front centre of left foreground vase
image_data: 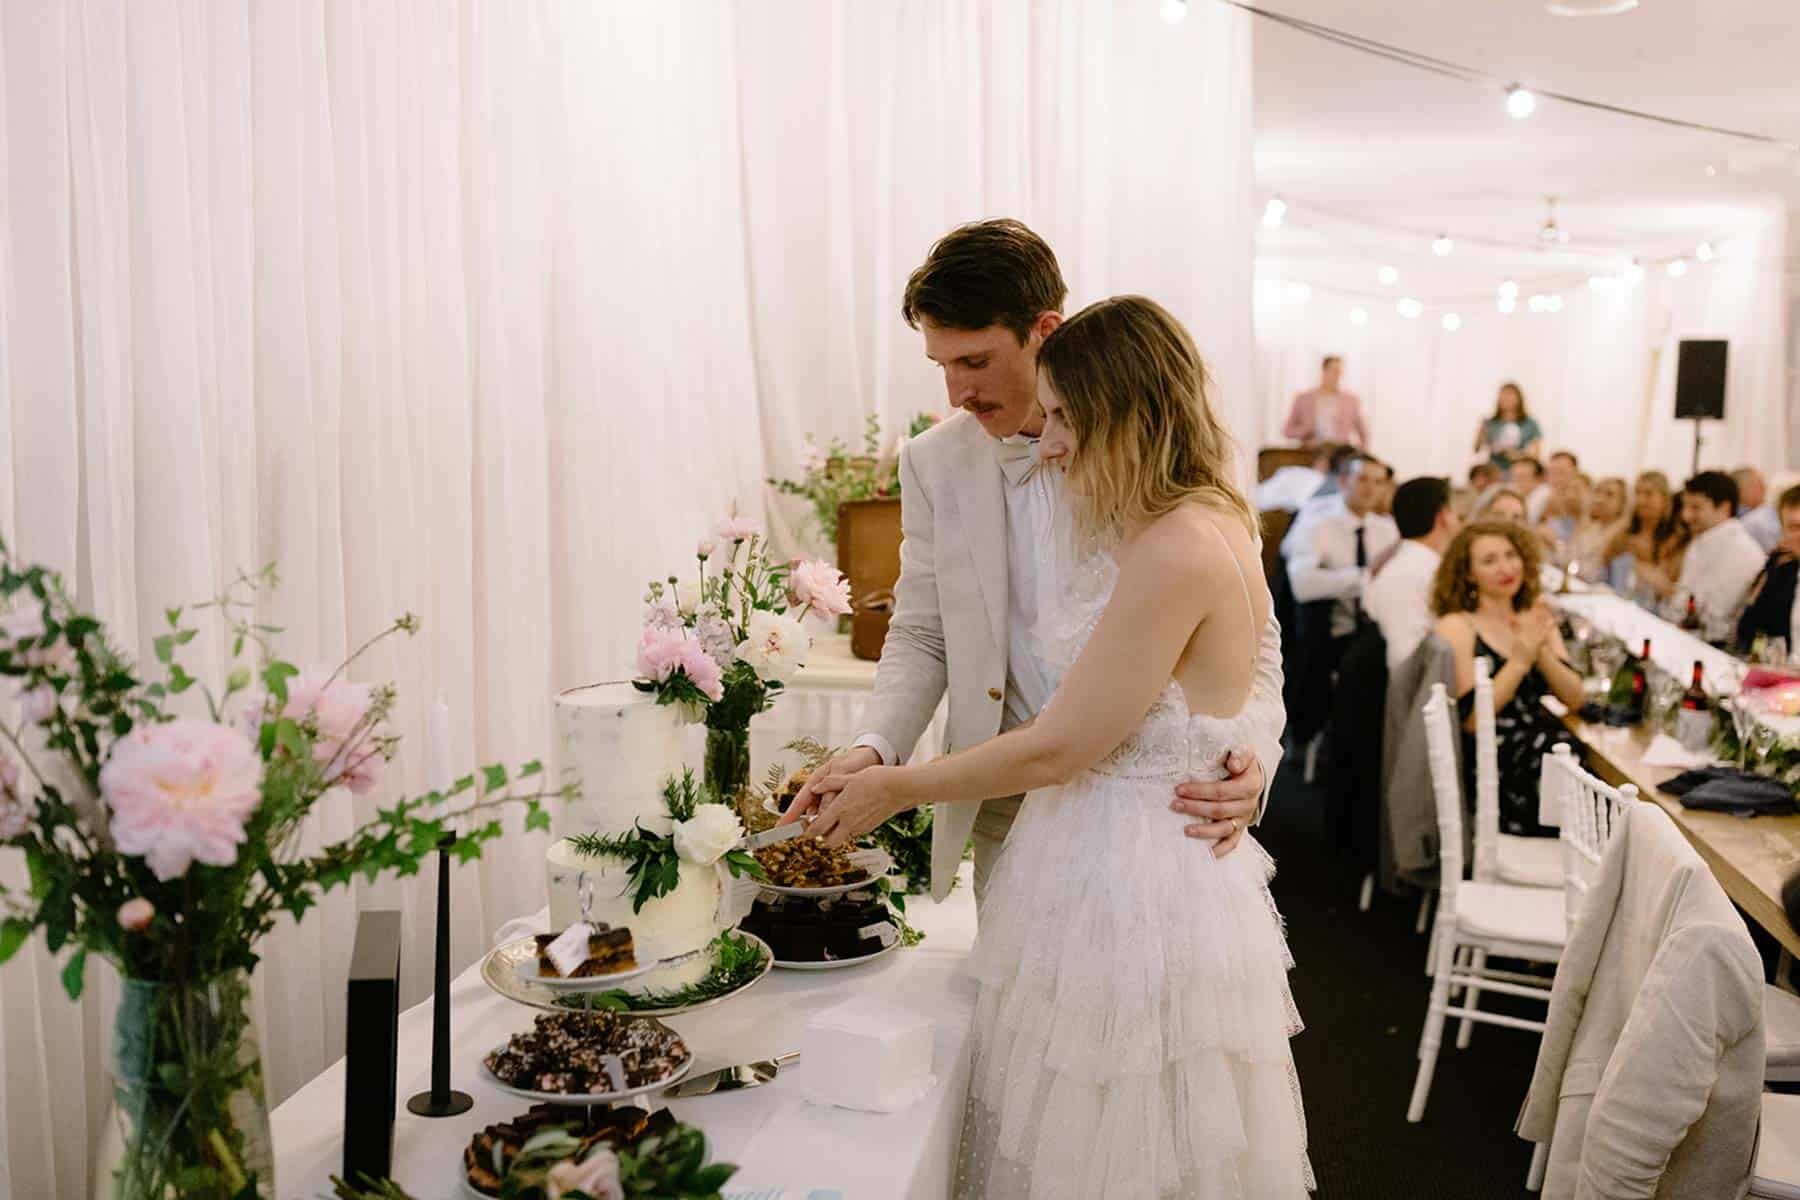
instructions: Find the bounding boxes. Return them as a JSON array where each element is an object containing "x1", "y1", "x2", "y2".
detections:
[{"x1": 101, "y1": 718, "x2": 263, "y2": 882}]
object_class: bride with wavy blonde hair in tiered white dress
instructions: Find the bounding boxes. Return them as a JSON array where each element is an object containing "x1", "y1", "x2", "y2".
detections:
[{"x1": 810, "y1": 297, "x2": 1312, "y2": 1200}]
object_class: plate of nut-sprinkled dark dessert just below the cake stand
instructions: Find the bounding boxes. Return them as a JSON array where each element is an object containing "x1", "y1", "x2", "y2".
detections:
[{"x1": 481, "y1": 1009, "x2": 693, "y2": 1105}]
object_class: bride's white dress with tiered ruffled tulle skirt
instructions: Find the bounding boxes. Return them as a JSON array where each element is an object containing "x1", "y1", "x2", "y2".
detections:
[{"x1": 958, "y1": 536, "x2": 1312, "y2": 1200}]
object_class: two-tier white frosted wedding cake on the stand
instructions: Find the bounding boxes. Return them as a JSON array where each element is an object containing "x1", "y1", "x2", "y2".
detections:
[{"x1": 545, "y1": 684, "x2": 724, "y2": 991}]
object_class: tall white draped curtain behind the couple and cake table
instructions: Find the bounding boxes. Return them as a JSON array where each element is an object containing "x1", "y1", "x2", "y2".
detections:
[{"x1": 0, "y1": 0, "x2": 1256, "y2": 1200}]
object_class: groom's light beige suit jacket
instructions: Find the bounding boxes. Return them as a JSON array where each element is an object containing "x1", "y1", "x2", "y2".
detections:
[{"x1": 862, "y1": 414, "x2": 1287, "y2": 900}]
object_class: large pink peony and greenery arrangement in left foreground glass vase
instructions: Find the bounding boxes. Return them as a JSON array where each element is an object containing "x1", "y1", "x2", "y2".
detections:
[{"x1": 0, "y1": 543, "x2": 572, "y2": 1200}]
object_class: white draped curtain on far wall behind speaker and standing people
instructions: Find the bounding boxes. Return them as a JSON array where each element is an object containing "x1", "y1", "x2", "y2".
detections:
[{"x1": 1255, "y1": 205, "x2": 1800, "y2": 482}]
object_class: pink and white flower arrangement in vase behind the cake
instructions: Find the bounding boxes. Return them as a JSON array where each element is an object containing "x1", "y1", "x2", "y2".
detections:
[{"x1": 634, "y1": 515, "x2": 850, "y2": 804}]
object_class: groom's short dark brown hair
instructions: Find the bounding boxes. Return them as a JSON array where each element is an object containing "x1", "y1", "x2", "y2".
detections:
[{"x1": 900, "y1": 218, "x2": 1069, "y2": 345}]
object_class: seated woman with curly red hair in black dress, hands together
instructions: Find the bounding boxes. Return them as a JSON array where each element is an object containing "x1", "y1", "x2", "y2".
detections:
[{"x1": 1431, "y1": 522, "x2": 1582, "y2": 837}]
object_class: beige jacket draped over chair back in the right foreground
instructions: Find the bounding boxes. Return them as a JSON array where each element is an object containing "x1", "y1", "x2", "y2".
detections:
[{"x1": 1519, "y1": 801, "x2": 1762, "y2": 1200}]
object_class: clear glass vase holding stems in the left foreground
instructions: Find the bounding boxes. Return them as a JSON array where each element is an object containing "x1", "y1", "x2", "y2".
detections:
[{"x1": 94, "y1": 972, "x2": 275, "y2": 1200}]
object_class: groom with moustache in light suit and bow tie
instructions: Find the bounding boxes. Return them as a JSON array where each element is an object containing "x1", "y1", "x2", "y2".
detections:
[{"x1": 790, "y1": 219, "x2": 1285, "y2": 901}]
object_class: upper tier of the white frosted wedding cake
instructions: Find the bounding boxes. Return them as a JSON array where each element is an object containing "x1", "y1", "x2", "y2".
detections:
[{"x1": 556, "y1": 684, "x2": 686, "y2": 837}]
